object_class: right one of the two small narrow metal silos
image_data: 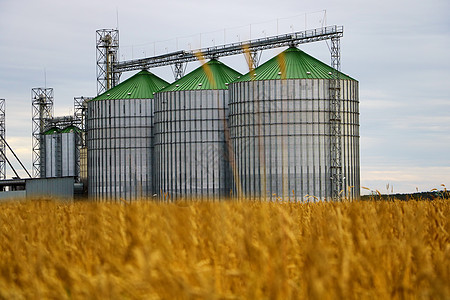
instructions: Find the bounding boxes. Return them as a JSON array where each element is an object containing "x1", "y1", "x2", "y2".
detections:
[{"x1": 60, "y1": 125, "x2": 80, "y2": 177}]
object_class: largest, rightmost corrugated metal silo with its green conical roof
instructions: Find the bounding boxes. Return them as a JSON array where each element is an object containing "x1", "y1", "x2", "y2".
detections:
[{"x1": 229, "y1": 47, "x2": 360, "y2": 200}]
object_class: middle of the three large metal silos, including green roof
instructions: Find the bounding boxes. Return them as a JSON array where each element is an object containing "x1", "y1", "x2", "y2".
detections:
[{"x1": 154, "y1": 59, "x2": 240, "y2": 197}]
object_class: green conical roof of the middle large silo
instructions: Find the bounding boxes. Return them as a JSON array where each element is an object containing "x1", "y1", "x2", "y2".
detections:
[{"x1": 160, "y1": 59, "x2": 241, "y2": 92}]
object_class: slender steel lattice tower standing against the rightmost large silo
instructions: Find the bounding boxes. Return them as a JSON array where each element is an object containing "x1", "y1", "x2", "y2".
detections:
[{"x1": 330, "y1": 37, "x2": 345, "y2": 200}]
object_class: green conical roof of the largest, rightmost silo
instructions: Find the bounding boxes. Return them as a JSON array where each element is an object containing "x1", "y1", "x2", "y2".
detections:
[{"x1": 235, "y1": 47, "x2": 354, "y2": 82}]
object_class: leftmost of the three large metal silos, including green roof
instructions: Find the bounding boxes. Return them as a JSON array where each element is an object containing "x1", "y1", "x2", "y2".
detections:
[{"x1": 87, "y1": 70, "x2": 168, "y2": 200}]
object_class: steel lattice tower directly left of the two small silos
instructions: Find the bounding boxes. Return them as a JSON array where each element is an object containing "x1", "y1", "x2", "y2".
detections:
[{"x1": 31, "y1": 88, "x2": 53, "y2": 177}]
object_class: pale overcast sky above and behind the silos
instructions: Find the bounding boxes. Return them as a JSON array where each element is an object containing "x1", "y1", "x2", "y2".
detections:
[{"x1": 0, "y1": 0, "x2": 450, "y2": 193}]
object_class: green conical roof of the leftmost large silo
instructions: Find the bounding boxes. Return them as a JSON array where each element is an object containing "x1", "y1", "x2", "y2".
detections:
[{"x1": 91, "y1": 70, "x2": 169, "y2": 101}]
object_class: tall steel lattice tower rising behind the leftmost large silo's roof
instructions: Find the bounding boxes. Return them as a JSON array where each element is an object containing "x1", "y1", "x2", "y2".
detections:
[{"x1": 96, "y1": 29, "x2": 120, "y2": 95}]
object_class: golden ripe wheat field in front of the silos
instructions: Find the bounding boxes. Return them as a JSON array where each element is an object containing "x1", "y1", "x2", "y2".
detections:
[{"x1": 0, "y1": 199, "x2": 450, "y2": 299}]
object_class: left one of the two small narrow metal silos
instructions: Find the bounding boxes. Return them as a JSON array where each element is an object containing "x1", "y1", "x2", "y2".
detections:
[{"x1": 41, "y1": 127, "x2": 61, "y2": 178}]
